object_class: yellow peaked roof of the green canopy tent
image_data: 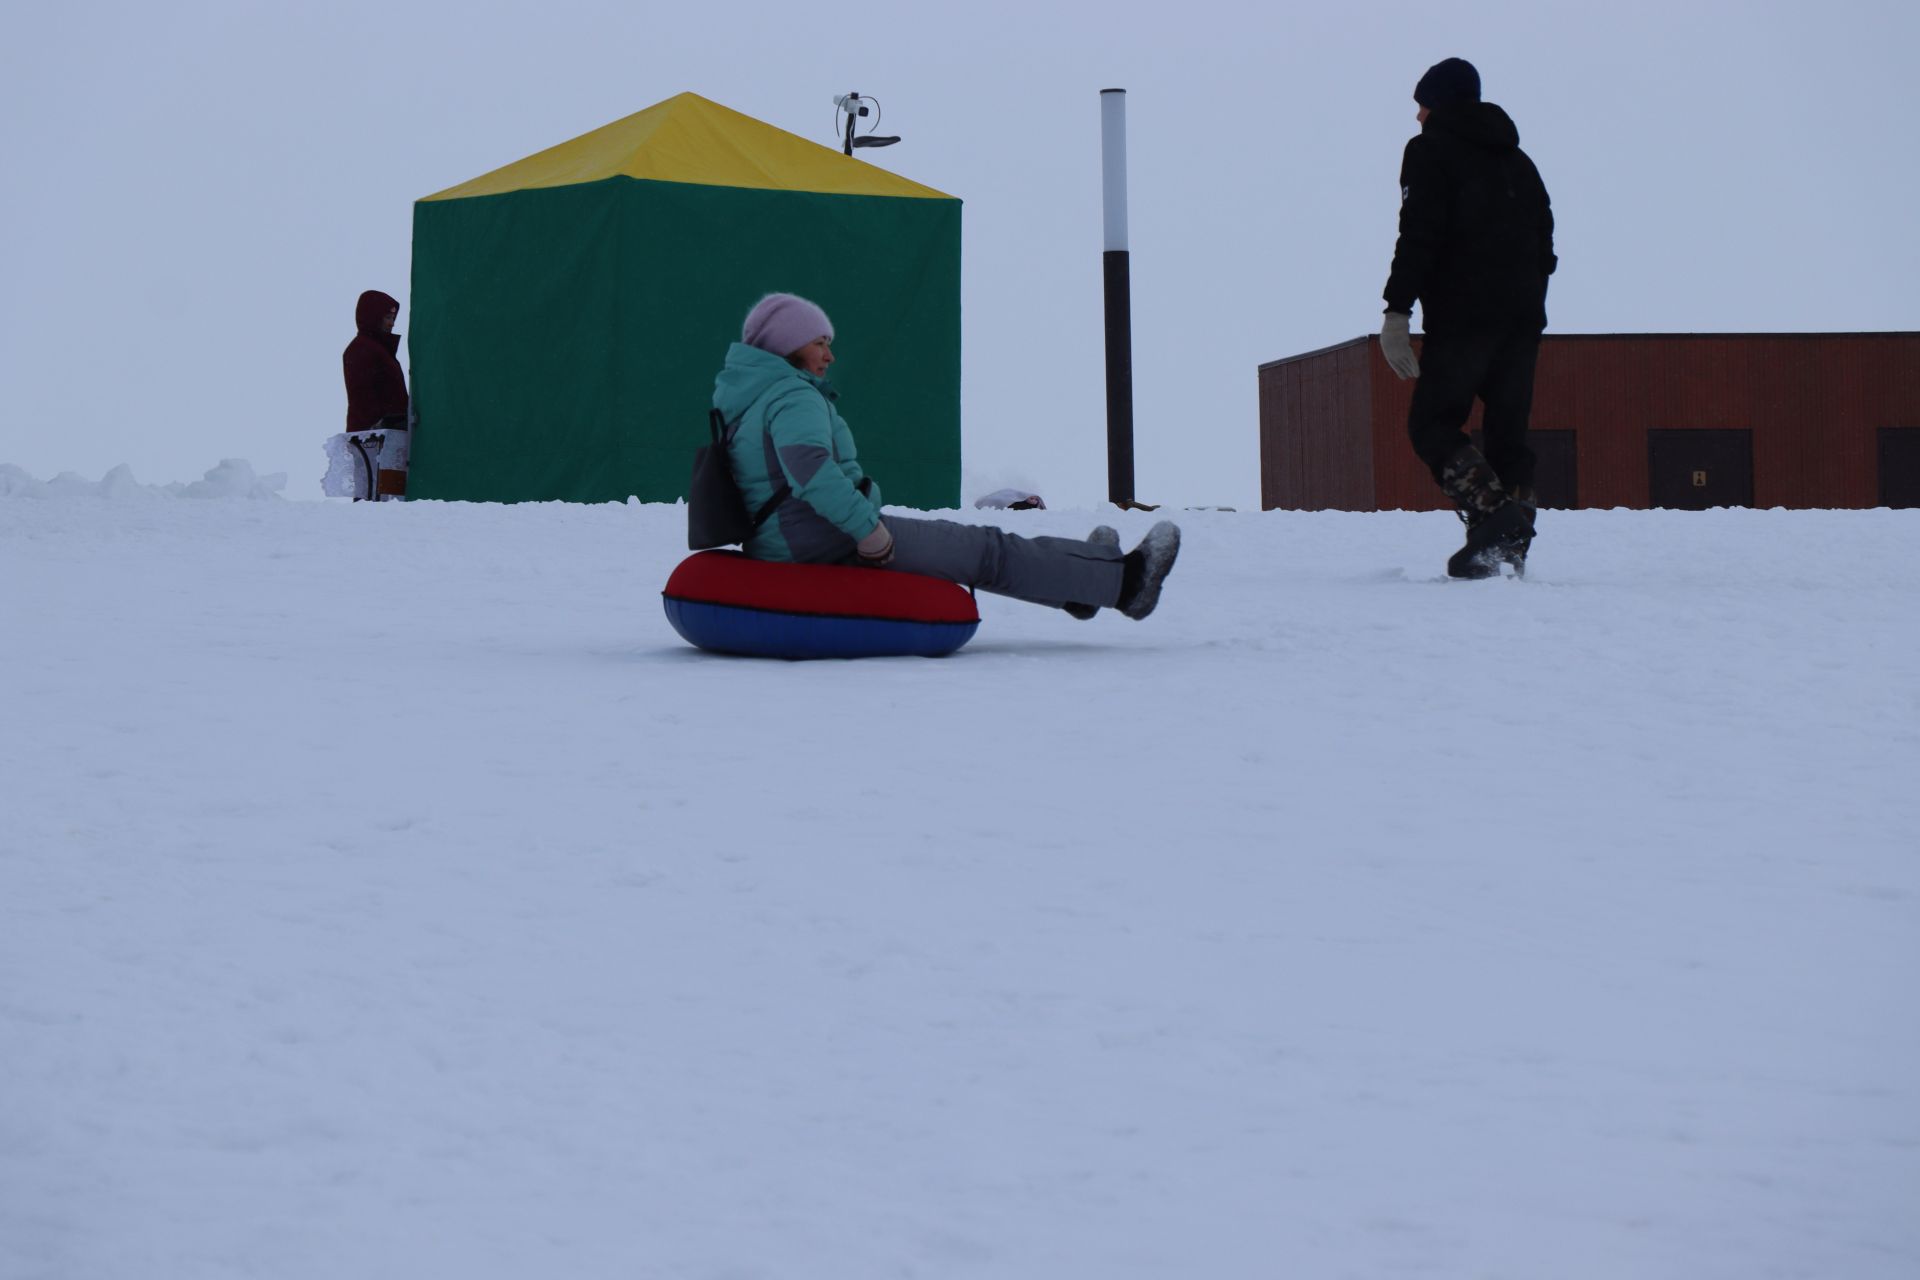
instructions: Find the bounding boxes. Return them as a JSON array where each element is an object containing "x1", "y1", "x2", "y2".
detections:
[{"x1": 426, "y1": 94, "x2": 952, "y2": 200}]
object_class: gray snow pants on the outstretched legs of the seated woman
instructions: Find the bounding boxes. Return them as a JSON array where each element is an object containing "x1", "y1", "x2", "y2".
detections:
[{"x1": 881, "y1": 514, "x2": 1123, "y2": 608}]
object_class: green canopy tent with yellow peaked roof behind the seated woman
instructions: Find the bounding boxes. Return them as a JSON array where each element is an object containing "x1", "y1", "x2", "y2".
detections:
[{"x1": 407, "y1": 94, "x2": 960, "y2": 509}]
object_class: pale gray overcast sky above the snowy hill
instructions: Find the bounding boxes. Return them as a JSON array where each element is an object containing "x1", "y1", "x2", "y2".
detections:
[{"x1": 0, "y1": 0, "x2": 1920, "y2": 509}]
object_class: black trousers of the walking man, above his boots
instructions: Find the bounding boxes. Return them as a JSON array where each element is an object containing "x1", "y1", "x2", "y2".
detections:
[{"x1": 1407, "y1": 324, "x2": 1540, "y2": 489}]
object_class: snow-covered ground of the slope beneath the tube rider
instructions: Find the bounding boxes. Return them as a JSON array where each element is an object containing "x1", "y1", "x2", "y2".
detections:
[{"x1": 0, "y1": 474, "x2": 1920, "y2": 1280}]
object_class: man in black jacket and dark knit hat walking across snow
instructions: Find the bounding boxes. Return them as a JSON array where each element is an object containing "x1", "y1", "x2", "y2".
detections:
[{"x1": 1380, "y1": 58, "x2": 1557, "y2": 578}]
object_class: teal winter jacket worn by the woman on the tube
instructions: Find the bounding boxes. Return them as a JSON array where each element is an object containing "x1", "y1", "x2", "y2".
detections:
[{"x1": 714, "y1": 342, "x2": 879, "y2": 564}]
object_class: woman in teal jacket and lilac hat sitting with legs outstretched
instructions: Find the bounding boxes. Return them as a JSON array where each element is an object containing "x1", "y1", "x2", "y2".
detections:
[{"x1": 714, "y1": 294, "x2": 1181, "y2": 618}]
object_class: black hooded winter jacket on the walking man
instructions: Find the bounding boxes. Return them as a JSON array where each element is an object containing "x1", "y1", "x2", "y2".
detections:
[{"x1": 1386, "y1": 102, "x2": 1559, "y2": 334}]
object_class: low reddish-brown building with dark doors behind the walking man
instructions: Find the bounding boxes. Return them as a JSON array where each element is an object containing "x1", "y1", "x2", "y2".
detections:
[{"x1": 1260, "y1": 332, "x2": 1920, "y2": 510}]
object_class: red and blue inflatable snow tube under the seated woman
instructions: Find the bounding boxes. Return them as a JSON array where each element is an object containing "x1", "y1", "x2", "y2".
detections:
[{"x1": 660, "y1": 551, "x2": 979, "y2": 658}]
